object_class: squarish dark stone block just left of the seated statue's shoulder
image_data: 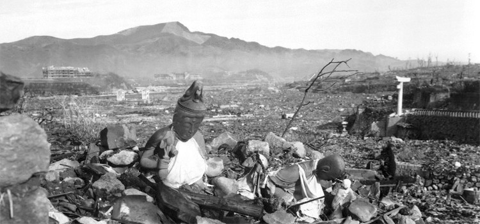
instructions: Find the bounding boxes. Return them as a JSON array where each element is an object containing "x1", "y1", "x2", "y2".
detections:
[{"x1": 100, "y1": 125, "x2": 137, "y2": 149}]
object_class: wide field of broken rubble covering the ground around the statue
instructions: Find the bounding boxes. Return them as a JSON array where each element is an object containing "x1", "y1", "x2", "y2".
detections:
[{"x1": 4, "y1": 87, "x2": 480, "y2": 224}]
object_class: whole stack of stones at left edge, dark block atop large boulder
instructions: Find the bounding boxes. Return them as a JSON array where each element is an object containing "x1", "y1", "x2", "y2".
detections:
[{"x1": 0, "y1": 72, "x2": 50, "y2": 224}]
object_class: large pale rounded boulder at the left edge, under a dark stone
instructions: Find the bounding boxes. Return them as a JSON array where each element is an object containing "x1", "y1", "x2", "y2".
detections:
[{"x1": 0, "y1": 114, "x2": 50, "y2": 186}]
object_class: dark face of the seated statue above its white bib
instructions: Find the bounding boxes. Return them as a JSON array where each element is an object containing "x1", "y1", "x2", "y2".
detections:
[{"x1": 173, "y1": 114, "x2": 203, "y2": 142}]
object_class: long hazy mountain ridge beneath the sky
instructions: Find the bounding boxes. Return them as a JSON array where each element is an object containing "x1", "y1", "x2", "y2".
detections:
[{"x1": 0, "y1": 22, "x2": 405, "y2": 78}]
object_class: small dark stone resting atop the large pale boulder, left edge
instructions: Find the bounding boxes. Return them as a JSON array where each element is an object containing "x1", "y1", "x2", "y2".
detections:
[{"x1": 0, "y1": 71, "x2": 24, "y2": 113}]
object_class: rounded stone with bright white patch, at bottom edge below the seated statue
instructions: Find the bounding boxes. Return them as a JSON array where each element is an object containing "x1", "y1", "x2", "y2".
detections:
[{"x1": 112, "y1": 195, "x2": 163, "y2": 224}]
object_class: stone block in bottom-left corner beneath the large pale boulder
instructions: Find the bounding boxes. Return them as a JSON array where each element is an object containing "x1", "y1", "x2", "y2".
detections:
[{"x1": 0, "y1": 188, "x2": 50, "y2": 224}]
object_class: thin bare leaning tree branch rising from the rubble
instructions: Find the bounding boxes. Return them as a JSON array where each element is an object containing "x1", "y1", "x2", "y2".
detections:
[{"x1": 282, "y1": 58, "x2": 357, "y2": 137}]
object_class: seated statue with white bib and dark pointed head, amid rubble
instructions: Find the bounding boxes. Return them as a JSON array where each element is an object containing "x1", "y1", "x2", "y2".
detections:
[{"x1": 140, "y1": 81, "x2": 207, "y2": 189}]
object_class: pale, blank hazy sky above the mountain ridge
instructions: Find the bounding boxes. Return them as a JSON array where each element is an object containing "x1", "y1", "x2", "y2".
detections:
[{"x1": 0, "y1": 0, "x2": 480, "y2": 63}]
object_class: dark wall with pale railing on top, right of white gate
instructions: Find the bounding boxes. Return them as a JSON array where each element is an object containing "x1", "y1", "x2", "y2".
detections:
[{"x1": 406, "y1": 110, "x2": 480, "y2": 143}]
